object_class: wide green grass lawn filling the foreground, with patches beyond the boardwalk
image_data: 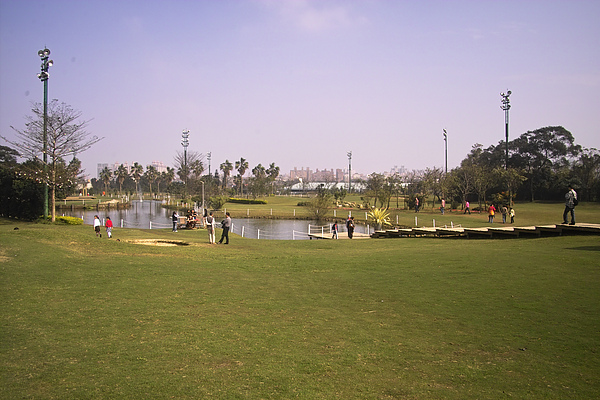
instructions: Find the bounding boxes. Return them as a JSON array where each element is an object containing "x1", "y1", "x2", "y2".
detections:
[{"x1": 0, "y1": 216, "x2": 600, "y2": 399}]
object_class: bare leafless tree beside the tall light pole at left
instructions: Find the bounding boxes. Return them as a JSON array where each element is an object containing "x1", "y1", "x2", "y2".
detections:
[{"x1": 0, "y1": 99, "x2": 103, "y2": 221}]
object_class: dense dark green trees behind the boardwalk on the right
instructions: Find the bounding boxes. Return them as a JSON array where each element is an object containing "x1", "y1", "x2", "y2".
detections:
[{"x1": 364, "y1": 126, "x2": 600, "y2": 208}]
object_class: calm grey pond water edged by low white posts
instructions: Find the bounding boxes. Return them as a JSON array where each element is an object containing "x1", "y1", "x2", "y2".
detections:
[{"x1": 57, "y1": 200, "x2": 368, "y2": 240}]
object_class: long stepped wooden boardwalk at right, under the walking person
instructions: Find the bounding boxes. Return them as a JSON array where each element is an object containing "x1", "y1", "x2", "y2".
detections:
[{"x1": 371, "y1": 223, "x2": 600, "y2": 238}]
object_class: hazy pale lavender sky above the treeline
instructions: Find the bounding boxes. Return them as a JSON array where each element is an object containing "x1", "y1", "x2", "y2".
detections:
[{"x1": 0, "y1": 0, "x2": 600, "y2": 177}]
